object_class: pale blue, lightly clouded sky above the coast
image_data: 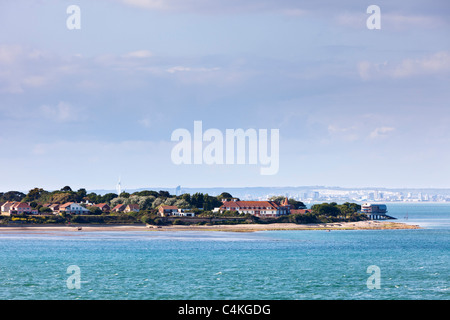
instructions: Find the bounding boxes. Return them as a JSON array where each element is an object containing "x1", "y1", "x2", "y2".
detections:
[{"x1": 0, "y1": 0, "x2": 450, "y2": 191}]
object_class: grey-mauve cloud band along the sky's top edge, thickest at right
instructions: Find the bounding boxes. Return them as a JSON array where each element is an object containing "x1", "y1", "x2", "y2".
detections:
[{"x1": 114, "y1": 0, "x2": 449, "y2": 25}]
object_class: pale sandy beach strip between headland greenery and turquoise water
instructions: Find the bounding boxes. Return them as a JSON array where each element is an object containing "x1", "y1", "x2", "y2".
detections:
[{"x1": 0, "y1": 220, "x2": 422, "y2": 233}]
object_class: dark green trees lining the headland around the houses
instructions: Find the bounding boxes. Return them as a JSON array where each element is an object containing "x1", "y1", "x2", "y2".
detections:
[{"x1": 0, "y1": 186, "x2": 362, "y2": 222}]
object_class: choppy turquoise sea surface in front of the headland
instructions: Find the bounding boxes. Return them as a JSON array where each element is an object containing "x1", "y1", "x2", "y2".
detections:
[{"x1": 0, "y1": 203, "x2": 450, "y2": 300}]
